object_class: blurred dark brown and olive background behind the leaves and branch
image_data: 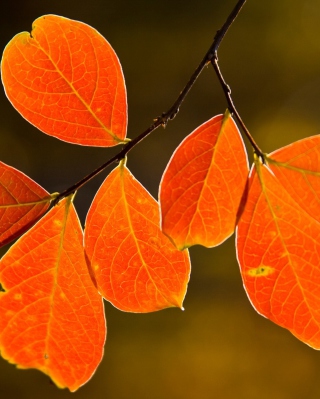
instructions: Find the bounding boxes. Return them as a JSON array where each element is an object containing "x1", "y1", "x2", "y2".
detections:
[{"x1": 0, "y1": 0, "x2": 320, "y2": 399}]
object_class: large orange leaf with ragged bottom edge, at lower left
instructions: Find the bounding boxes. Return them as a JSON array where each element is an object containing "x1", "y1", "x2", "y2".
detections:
[{"x1": 0, "y1": 198, "x2": 106, "y2": 391}]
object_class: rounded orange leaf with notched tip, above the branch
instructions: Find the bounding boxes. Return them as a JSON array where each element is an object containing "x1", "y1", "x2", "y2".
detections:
[{"x1": 1, "y1": 15, "x2": 127, "y2": 147}]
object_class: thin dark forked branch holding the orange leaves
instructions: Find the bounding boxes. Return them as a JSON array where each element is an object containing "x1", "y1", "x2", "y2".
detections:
[{"x1": 52, "y1": 0, "x2": 250, "y2": 205}]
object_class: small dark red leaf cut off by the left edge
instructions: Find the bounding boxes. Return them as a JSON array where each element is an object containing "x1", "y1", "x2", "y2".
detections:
[{"x1": 0, "y1": 162, "x2": 51, "y2": 246}]
